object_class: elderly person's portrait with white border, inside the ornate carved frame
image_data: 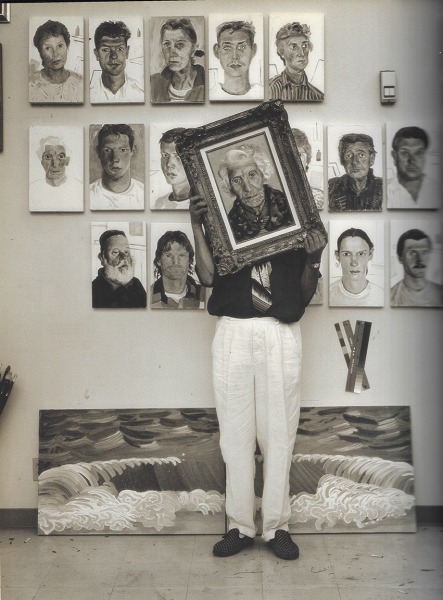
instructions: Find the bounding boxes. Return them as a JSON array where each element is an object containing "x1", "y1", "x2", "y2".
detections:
[{"x1": 203, "y1": 128, "x2": 300, "y2": 248}]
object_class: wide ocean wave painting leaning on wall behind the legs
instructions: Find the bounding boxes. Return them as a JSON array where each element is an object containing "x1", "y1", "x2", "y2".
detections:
[{"x1": 38, "y1": 407, "x2": 415, "y2": 535}]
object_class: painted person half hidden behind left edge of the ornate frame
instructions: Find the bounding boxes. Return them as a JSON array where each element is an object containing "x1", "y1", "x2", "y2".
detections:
[{"x1": 152, "y1": 127, "x2": 190, "y2": 210}]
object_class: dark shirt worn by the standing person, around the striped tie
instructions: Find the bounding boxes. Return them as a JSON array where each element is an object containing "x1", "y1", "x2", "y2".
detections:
[{"x1": 208, "y1": 249, "x2": 306, "y2": 323}]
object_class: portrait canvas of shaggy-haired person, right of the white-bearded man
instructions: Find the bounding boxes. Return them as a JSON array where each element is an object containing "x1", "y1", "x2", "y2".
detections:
[{"x1": 150, "y1": 222, "x2": 205, "y2": 309}]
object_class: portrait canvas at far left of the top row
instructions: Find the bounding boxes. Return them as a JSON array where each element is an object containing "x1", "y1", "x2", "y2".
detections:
[{"x1": 28, "y1": 16, "x2": 84, "y2": 104}]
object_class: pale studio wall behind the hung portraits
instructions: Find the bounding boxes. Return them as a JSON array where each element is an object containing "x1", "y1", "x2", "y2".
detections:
[{"x1": 0, "y1": 0, "x2": 443, "y2": 508}]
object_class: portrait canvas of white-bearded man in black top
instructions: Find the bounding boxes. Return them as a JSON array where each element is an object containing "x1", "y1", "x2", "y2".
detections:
[{"x1": 91, "y1": 221, "x2": 147, "y2": 308}]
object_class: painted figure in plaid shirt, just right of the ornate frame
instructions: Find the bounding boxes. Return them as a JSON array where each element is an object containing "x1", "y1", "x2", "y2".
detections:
[{"x1": 328, "y1": 133, "x2": 383, "y2": 211}]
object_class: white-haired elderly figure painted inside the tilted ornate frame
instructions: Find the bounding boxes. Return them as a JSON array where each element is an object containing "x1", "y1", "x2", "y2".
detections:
[{"x1": 218, "y1": 144, "x2": 294, "y2": 242}]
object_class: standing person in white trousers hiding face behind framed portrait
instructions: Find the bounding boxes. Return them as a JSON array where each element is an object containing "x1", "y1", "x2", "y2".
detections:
[{"x1": 190, "y1": 197, "x2": 327, "y2": 560}]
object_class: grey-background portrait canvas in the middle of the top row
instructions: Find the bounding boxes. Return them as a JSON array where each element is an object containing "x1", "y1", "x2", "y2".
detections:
[{"x1": 149, "y1": 17, "x2": 206, "y2": 104}]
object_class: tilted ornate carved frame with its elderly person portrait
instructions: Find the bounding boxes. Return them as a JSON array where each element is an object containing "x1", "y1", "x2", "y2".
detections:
[{"x1": 176, "y1": 101, "x2": 326, "y2": 275}]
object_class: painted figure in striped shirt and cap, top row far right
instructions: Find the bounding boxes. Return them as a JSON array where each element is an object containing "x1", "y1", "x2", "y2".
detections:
[{"x1": 269, "y1": 21, "x2": 324, "y2": 102}]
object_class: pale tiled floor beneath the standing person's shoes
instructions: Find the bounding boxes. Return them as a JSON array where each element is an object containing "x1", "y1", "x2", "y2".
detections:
[{"x1": 0, "y1": 526, "x2": 443, "y2": 600}]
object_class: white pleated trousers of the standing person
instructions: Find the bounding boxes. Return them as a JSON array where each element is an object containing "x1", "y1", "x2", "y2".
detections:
[{"x1": 212, "y1": 317, "x2": 302, "y2": 541}]
